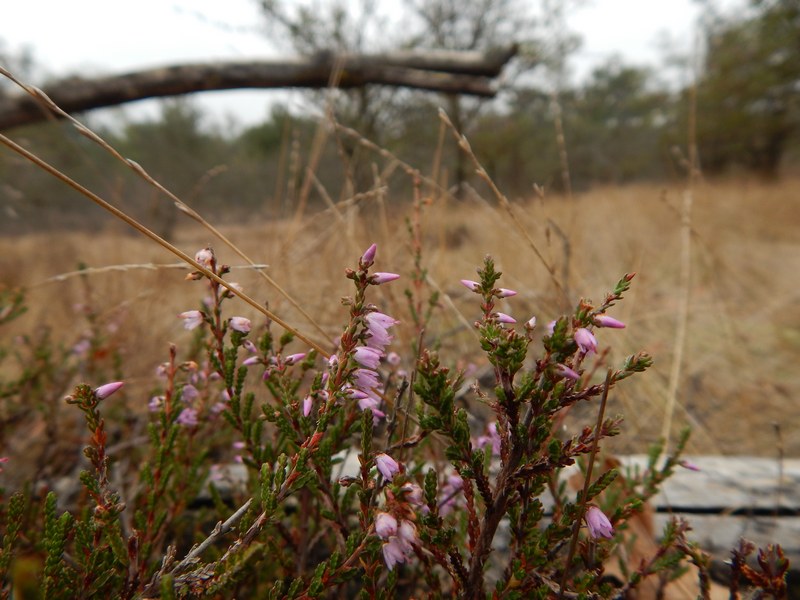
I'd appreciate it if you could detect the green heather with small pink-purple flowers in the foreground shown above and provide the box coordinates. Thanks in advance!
[0,67,788,598]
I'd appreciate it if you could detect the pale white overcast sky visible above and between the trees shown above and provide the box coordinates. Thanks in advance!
[0,0,736,129]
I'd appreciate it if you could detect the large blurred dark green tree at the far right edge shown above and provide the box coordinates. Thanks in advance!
[697,0,800,178]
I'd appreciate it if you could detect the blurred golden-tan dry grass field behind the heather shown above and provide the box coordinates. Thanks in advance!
[0,174,800,456]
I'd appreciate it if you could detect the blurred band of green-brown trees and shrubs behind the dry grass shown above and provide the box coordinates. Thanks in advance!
[0,0,800,233]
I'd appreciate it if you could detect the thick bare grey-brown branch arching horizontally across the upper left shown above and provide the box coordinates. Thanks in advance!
[0,47,516,130]
